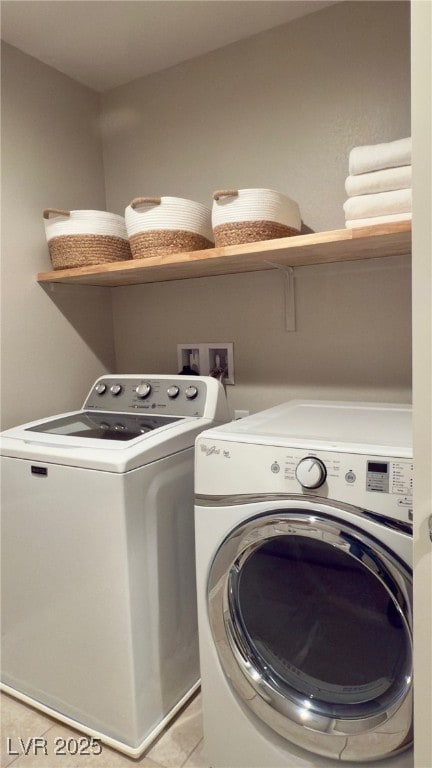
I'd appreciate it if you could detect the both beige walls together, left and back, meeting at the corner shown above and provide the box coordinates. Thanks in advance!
[2,2,411,426]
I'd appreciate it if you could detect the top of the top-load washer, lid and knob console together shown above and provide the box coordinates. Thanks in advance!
[0,374,228,473]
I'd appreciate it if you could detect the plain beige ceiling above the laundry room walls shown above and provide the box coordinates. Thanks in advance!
[1,0,336,92]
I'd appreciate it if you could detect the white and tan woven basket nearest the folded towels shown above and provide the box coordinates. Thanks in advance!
[212,189,301,247]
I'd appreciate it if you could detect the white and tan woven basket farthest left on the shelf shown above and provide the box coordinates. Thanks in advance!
[43,208,132,269]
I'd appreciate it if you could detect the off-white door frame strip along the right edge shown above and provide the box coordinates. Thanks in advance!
[412,0,432,768]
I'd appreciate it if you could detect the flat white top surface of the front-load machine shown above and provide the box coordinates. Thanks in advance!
[201,400,412,457]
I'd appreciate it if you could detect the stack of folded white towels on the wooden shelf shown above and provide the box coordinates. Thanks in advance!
[343,137,412,228]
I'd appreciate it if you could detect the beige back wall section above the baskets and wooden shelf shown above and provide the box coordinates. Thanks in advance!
[102,0,410,232]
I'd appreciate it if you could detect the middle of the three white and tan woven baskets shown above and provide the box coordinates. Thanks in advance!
[125,197,213,259]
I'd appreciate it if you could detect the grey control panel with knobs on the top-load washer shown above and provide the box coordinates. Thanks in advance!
[83,376,207,416]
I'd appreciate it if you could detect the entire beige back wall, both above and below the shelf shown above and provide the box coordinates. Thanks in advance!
[102,1,411,411]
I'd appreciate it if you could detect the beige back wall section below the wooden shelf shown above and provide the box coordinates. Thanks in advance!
[109,257,411,411]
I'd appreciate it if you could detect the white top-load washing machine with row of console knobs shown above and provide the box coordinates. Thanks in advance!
[1,375,228,756]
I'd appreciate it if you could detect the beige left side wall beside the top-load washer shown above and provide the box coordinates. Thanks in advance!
[1,43,115,429]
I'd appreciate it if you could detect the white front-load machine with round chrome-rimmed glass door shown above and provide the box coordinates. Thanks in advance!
[195,401,413,768]
